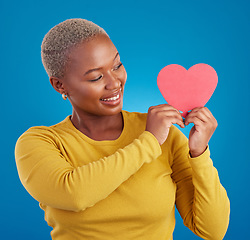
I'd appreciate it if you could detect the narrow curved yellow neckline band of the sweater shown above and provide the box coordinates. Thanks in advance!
[65,110,127,145]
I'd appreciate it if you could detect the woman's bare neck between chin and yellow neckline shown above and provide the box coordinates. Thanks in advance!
[71,110,123,141]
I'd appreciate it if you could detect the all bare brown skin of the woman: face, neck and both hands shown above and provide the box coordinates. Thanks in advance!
[50,34,217,157]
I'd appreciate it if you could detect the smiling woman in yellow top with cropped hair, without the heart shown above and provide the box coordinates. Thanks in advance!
[15,19,229,240]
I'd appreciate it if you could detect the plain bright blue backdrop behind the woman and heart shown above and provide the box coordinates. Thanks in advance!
[0,0,250,240]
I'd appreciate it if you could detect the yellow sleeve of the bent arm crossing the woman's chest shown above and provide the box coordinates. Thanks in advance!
[15,129,161,212]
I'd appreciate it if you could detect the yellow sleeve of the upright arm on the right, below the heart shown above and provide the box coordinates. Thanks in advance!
[172,128,230,240]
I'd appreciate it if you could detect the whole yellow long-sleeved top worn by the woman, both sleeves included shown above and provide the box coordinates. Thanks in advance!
[15,111,230,240]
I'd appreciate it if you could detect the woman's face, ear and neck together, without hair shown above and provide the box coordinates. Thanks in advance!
[50,34,127,140]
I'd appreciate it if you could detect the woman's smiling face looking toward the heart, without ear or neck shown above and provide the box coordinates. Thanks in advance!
[63,34,127,116]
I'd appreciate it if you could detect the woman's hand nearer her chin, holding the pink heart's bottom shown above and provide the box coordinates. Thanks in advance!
[146,104,185,145]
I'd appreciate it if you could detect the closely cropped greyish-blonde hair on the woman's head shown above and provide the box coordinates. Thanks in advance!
[41,18,107,78]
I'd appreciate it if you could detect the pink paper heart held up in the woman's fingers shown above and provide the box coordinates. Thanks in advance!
[157,63,218,118]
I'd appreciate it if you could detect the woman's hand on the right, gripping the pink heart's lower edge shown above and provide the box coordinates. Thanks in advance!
[184,107,218,157]
